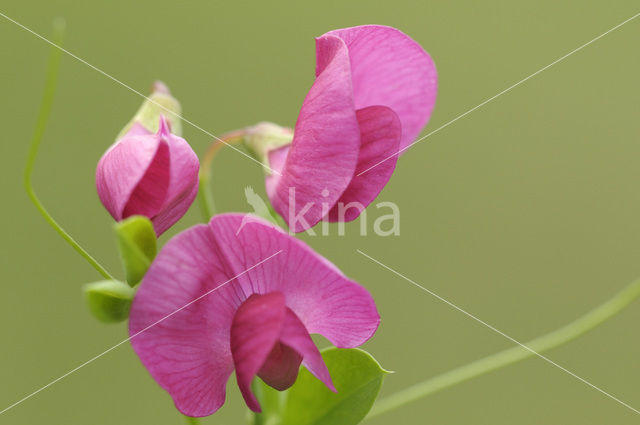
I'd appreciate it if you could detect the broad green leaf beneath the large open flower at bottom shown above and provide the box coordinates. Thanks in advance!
[254,348,389,425]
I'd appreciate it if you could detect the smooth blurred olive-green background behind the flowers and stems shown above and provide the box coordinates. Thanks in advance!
[0,0,640,425]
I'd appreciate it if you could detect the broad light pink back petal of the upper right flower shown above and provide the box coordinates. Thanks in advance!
[316,25,438,149]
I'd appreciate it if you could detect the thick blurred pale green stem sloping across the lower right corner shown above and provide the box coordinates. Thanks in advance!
[367,279,640,419]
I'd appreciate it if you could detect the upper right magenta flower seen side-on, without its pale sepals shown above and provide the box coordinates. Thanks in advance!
[266,25,437,232]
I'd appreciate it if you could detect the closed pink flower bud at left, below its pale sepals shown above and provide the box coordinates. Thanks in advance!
[96,116,200,236]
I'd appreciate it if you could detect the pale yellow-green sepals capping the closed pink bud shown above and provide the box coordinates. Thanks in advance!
[116,81,182,141]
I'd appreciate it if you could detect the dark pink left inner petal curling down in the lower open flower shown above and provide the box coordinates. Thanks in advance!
[231,292,286,412]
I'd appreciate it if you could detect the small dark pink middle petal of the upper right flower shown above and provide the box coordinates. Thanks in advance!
[329,106,402,222]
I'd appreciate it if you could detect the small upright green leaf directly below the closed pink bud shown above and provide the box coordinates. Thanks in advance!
[115,215,157,286]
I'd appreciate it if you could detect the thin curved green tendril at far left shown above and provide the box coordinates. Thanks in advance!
[24,20,113,279]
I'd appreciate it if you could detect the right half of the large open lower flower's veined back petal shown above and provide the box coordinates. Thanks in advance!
[209,214,380,348]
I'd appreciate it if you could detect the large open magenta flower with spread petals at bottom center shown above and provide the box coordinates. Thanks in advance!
[129,214,380,416]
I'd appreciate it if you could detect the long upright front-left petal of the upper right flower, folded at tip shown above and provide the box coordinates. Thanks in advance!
[266,37,360,232]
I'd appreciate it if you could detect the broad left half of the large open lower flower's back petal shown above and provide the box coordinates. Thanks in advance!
[129,225,239,416]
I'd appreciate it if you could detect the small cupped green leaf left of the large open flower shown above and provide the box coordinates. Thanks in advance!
[83,280,136,323]
